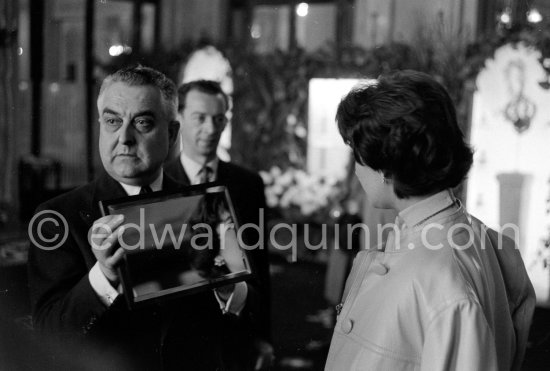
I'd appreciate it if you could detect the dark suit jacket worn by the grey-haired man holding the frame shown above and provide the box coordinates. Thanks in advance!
[28,174,253,370]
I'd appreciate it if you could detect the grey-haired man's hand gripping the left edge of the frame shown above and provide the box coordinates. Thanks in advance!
[89,215,124,286]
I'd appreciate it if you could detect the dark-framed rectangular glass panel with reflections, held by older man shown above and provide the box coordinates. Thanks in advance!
[103,186,250,304]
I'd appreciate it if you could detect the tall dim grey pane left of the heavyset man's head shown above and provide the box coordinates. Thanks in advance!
[41,0,87,188]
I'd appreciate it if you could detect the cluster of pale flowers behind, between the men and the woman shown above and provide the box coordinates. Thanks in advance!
[260,166,339,222]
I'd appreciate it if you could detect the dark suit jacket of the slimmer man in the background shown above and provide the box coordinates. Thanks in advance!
[164,156,271,340]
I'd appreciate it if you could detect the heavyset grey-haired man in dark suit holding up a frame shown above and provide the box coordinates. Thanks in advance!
[29,66,262,370]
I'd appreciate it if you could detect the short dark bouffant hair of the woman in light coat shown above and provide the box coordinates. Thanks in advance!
[336,71,473,198]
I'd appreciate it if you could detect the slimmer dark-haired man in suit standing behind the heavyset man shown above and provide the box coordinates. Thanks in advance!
[165,80,272,368]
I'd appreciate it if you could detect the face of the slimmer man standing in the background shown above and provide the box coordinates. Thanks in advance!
[178,90,227,163]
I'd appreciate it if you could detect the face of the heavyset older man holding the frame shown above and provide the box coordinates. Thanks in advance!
[97,82,178,186]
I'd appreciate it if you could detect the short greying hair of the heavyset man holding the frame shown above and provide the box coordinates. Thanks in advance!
[99,65,178,119]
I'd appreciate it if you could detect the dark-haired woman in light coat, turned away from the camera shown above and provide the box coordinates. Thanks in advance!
[326,71,535,371]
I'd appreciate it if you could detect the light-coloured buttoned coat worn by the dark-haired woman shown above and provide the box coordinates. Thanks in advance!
[325,192,535,371]
